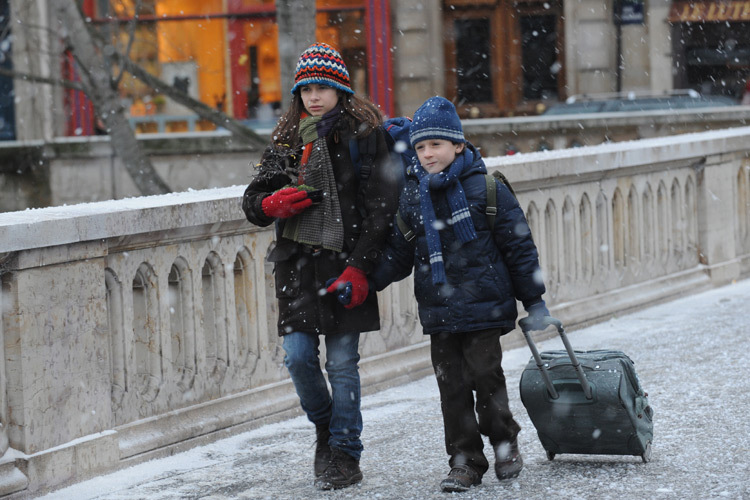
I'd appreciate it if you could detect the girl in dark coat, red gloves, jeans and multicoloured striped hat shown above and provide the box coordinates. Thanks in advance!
[242,43,398,489]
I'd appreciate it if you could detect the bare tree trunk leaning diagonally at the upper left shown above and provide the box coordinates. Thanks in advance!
[52,0,170,195]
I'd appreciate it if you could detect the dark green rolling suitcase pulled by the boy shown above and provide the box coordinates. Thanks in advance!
[520,318,653,462]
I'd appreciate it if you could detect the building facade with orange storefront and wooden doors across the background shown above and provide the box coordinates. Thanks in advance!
[0,0,750,139]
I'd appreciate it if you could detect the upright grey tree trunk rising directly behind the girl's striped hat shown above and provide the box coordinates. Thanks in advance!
[276,0,316,109]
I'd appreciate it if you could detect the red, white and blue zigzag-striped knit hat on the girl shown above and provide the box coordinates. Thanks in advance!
[292,43,354,94]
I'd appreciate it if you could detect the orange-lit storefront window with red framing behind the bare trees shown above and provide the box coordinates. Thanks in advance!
[87,0,368,132]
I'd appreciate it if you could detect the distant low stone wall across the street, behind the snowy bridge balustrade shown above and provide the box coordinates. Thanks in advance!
[0,105,750,212]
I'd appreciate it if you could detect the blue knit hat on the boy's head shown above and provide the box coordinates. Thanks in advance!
[409,96,466,147]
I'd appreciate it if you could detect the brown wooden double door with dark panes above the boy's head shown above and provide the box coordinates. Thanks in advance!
[443,0,564,118]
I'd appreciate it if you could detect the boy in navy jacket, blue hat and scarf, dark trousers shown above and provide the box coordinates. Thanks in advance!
[371,97,549,492]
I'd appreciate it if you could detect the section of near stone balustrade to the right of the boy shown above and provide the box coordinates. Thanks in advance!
[487,127,750,324]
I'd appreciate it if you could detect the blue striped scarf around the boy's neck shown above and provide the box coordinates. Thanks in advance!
[412,149,477,285]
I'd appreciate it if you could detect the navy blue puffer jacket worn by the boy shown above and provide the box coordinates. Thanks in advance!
[370,143,546,334]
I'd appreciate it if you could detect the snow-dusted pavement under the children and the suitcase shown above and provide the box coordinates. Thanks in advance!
[42,280,750,500]
